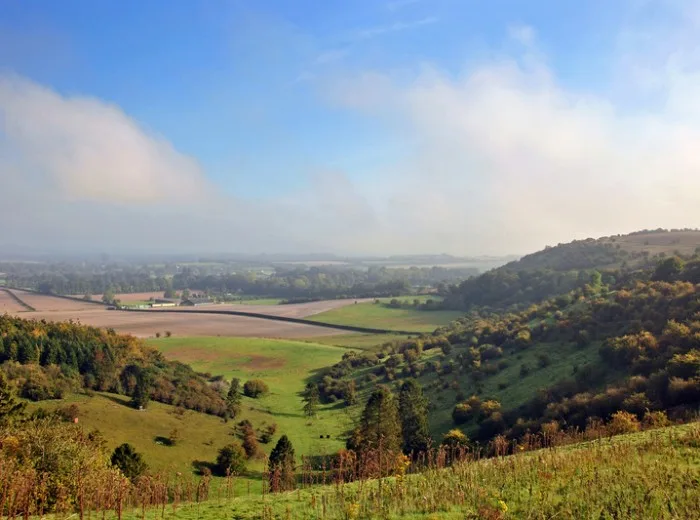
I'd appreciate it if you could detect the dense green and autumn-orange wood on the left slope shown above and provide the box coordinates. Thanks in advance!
[0,315,229,416]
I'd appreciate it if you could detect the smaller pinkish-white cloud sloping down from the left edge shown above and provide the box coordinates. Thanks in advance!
[0,76,209,204]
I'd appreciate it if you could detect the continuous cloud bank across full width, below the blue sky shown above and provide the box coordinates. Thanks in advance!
[0,3,700,254]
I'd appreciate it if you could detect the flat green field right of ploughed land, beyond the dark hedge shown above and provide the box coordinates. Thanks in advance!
[309,299,462,332]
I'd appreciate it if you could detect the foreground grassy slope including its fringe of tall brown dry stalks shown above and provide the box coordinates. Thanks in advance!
[8,423,700,520]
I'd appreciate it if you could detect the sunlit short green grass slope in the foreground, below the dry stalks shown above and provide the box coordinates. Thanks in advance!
[116,423,700,520]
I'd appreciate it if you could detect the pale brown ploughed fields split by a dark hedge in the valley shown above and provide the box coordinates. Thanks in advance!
[0,290,354,338]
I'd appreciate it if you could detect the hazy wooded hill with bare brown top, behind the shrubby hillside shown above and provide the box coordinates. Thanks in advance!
[444,229,700,310]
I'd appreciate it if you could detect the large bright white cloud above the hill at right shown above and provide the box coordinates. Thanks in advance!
[322,18,700,253]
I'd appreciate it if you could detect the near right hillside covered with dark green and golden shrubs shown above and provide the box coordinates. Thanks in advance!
[321,255,700,442]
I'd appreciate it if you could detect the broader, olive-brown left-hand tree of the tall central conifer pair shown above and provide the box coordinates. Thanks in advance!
[358,386,403,452]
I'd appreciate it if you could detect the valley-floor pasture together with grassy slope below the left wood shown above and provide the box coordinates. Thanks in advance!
[30,337,356,492]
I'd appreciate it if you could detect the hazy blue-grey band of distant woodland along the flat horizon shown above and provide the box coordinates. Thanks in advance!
[0,264,478,299]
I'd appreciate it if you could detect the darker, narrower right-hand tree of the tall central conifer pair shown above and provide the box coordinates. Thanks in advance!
[399,378,430,454]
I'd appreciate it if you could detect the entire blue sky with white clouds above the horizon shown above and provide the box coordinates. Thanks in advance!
[0,0,700,255]
